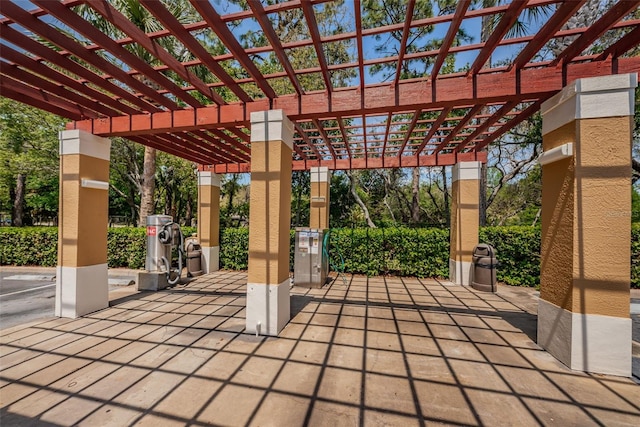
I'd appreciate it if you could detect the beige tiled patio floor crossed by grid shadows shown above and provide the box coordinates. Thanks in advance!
[0,271,640,426]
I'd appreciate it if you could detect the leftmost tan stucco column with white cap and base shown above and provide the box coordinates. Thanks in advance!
[55,130,111,318]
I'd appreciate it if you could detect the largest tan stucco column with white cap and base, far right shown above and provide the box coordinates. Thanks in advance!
[538,74,637,376]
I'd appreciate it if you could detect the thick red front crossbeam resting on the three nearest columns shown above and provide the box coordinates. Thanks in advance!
[72,57,640,136]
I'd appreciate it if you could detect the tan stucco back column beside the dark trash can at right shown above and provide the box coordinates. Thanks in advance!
[449,162,482,286]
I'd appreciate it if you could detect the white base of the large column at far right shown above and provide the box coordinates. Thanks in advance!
[538,300,632,377]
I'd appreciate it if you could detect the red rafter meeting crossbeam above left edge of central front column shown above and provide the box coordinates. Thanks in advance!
[140,0,251,102]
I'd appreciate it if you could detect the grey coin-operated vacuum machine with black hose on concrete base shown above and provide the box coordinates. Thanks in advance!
[138,215,202,291]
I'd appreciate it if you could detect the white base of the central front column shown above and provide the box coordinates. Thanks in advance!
[246,279,291,336]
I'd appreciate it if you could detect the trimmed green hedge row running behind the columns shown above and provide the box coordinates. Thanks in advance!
[0,224,640,288]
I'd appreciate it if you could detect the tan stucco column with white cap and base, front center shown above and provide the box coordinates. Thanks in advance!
[246,110,293,335]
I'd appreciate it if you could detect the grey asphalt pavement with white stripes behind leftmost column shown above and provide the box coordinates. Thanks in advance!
[0,267,137,329]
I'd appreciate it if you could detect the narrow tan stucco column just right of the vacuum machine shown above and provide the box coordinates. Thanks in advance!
[198,171,220,273]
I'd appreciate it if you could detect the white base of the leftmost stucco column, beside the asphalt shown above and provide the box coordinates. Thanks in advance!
[55,264,109,319]
